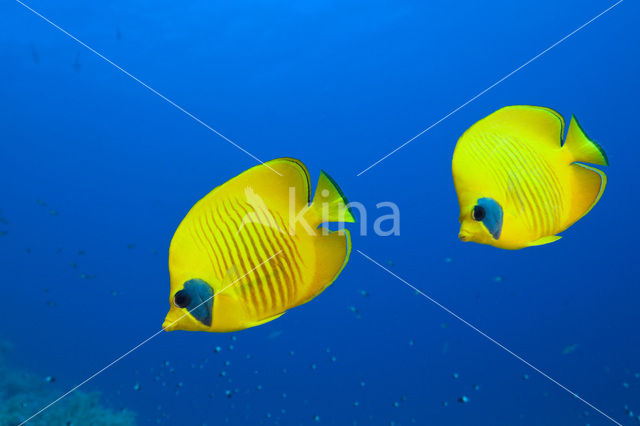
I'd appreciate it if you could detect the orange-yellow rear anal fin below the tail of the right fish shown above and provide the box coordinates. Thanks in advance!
[566,163,607,227]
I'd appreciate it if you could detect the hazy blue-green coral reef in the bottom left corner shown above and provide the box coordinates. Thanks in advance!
[0,341,135,426]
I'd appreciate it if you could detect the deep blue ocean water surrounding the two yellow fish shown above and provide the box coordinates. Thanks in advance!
[0,0,640,425]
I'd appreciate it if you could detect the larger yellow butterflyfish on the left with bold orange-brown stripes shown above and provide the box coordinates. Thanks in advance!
[163,158,355,332]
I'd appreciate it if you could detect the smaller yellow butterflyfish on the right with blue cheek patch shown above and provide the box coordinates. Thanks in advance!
[452,105,609,249]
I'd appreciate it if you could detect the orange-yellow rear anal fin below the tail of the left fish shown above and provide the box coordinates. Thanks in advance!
[301,229,351,303]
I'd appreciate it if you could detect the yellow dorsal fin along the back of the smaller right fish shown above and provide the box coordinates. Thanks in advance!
[472,105,564,148]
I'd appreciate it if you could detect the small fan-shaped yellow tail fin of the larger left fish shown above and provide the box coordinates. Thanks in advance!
[309,170,356,226]
